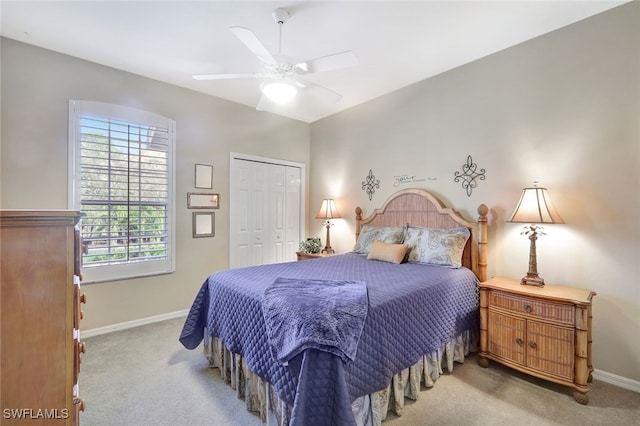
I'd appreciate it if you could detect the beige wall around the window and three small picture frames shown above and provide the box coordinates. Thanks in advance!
[0,39,309,329]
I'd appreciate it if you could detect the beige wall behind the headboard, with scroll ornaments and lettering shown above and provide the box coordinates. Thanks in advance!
[308,2,640,381]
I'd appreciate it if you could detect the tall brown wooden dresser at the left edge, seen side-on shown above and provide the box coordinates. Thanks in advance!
[0,210,86,425]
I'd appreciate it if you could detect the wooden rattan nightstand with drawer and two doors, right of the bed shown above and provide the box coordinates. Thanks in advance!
[478,277,596,404]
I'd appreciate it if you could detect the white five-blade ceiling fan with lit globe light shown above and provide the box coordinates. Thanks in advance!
[192,8,358,115]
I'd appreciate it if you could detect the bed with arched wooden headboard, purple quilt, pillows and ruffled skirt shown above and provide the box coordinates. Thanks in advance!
[179,189,488,426]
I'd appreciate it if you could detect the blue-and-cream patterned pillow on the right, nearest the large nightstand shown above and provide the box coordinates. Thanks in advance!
[404,227,471,268]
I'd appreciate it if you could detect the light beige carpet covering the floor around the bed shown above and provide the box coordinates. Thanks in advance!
[80,319,640,426]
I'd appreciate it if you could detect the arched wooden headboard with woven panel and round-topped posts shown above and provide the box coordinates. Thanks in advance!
[356,189,489,281]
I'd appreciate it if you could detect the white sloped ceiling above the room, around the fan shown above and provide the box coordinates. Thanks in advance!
[0,0,626,122]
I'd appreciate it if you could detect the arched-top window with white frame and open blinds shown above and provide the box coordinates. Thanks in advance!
[69,101,175,282]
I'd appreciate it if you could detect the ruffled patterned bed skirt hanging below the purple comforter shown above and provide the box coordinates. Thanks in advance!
[203,331,478,426]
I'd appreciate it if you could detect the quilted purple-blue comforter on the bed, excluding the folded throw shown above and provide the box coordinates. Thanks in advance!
[180,254,478,425]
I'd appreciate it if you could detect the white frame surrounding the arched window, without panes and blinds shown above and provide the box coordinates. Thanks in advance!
[68,100,176,283]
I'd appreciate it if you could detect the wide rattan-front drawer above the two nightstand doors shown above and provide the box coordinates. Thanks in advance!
[489,291,575,325]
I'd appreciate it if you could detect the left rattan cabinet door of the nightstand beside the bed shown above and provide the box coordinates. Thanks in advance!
[488,309,526,365]
